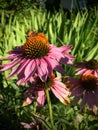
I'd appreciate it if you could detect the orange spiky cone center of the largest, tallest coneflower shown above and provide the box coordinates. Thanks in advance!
[23,31,49,59]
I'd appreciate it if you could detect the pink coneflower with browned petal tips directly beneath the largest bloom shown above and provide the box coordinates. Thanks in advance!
[23,75,70,106]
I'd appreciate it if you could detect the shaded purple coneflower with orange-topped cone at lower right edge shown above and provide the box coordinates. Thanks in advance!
[67,74,98,109]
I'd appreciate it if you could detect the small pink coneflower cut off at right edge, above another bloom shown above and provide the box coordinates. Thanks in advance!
[76,59,98,77]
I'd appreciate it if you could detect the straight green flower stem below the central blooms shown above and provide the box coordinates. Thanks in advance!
[45,88,55,130]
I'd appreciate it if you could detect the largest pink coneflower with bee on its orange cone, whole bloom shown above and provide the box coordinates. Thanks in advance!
[0,31,75,85]
